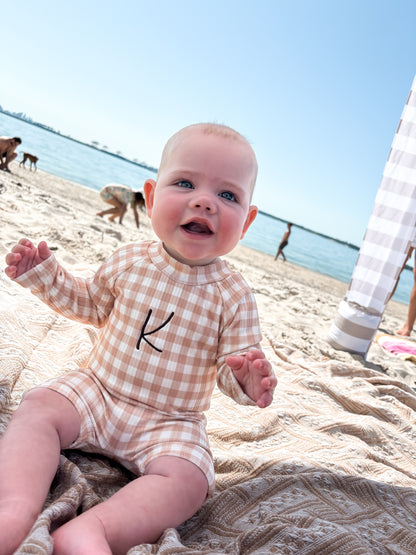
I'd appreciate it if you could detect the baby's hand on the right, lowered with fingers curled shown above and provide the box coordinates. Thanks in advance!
[225,349,277,409]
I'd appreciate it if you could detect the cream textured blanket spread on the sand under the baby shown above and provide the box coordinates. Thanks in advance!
[0,280,416,555]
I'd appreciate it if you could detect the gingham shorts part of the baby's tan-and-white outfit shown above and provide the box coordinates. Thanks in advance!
[42,370,215,494]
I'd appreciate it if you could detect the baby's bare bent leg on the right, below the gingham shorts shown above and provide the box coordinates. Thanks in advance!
[53,456,208,555]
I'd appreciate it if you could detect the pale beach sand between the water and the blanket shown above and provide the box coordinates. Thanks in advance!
[0,163,416,388]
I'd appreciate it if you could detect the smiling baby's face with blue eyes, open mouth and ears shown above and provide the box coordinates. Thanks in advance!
[144,128,257,266]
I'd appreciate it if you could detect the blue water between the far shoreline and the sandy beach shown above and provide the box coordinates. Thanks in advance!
[0,112,413,304]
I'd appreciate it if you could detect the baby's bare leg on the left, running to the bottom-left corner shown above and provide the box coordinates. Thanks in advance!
[0,388,80,555]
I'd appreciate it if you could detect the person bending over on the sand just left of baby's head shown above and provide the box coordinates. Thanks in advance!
[97,183,145,228]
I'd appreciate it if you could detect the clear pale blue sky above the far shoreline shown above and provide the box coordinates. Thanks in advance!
[0,0,416,244]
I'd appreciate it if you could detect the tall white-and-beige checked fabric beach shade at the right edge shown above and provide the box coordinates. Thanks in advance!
[326,77,416,356]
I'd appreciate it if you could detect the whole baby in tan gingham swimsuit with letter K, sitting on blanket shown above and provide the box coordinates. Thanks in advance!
[0,124,277,555]
